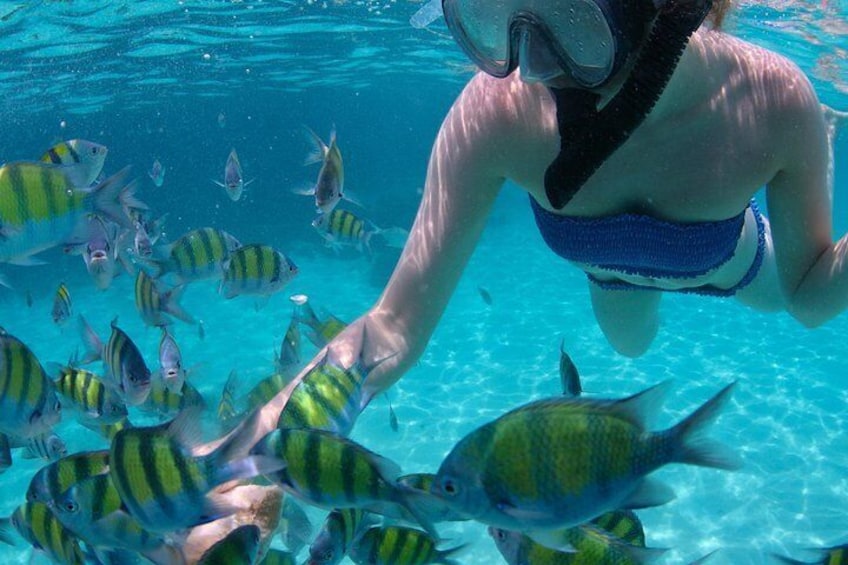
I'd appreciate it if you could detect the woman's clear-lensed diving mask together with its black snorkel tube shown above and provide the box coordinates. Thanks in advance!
[440,0,712,209]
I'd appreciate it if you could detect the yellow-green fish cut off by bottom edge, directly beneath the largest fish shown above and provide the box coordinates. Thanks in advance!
[489,523,666,565]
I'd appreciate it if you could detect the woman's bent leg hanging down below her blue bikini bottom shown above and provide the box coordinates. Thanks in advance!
[589,281,662,357]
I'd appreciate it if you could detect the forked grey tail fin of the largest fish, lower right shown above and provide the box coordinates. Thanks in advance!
[667,381,742,471]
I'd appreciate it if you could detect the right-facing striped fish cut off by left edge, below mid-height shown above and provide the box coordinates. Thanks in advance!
[0,328,62,438]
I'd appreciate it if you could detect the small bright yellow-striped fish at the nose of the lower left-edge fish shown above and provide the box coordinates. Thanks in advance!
[56,367,127,424]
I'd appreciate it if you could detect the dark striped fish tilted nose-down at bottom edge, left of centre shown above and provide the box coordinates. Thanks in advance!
[304,508,378,565]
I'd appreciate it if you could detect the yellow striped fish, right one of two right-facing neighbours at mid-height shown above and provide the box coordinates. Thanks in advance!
[219,245,298,299]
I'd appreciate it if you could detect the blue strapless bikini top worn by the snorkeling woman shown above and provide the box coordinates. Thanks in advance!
[530,196,756,278]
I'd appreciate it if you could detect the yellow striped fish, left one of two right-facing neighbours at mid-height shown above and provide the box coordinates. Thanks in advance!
[141,228,241,284]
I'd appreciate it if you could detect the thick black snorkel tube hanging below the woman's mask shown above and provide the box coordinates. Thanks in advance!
[545,0,712,210]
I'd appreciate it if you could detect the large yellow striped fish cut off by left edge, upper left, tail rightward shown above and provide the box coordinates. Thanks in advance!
[0,162,139,265]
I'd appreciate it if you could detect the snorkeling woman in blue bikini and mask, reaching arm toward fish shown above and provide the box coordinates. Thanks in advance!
[266,0,848,418]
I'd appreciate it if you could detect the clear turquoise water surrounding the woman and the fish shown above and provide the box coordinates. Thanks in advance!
[0,0,848,564]
